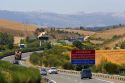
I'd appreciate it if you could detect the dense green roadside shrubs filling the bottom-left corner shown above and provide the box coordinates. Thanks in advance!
[0,61,41,83]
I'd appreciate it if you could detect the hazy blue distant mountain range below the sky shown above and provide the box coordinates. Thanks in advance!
[0,10,125,27]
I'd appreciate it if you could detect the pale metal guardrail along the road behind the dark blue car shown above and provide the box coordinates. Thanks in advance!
[58,69,125,81]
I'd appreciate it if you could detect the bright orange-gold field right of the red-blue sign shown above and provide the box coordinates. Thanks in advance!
[96,50,125,64]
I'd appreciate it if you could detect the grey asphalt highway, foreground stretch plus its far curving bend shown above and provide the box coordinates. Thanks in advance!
[2,51,125,83]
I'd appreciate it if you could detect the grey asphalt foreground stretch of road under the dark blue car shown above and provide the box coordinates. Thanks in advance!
[47,73,125,83]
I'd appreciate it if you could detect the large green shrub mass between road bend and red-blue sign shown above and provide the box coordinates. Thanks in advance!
[30,47,69,67]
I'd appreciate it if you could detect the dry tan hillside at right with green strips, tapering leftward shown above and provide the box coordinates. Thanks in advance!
[60,27,125,49]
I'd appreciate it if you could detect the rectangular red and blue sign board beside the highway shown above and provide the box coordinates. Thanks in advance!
[71,50,95,64]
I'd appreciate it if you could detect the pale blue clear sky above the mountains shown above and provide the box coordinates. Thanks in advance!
[0,0,125,14]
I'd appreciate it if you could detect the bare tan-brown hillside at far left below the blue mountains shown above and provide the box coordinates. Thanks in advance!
[0,19,36,36]
